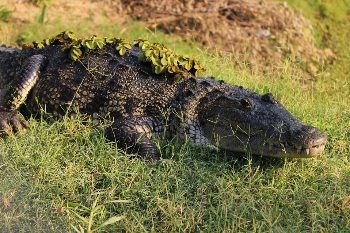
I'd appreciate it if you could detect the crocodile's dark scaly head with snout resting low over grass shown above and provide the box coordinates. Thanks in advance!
[197,82,327,158]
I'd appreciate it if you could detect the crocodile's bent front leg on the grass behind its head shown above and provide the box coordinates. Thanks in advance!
[105,117,163,160]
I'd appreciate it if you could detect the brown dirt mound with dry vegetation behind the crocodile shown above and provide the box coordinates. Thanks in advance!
[118,0,335,74]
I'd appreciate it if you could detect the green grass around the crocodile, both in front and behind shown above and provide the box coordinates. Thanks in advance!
[0,1,350,232]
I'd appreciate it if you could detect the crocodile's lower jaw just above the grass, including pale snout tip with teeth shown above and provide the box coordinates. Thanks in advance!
[203,125,327,158]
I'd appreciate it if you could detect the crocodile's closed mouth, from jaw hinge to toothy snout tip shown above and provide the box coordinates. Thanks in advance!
[202,111,327,158]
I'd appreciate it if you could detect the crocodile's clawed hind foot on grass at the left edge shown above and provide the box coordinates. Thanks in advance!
[0,111,28,137]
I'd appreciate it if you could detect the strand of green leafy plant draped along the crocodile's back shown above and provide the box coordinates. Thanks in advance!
[33,31,204,80]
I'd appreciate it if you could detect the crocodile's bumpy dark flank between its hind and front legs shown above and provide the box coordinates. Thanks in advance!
[28,46,180,121]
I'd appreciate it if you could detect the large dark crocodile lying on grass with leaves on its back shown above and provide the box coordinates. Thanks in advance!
[0,32,327,160]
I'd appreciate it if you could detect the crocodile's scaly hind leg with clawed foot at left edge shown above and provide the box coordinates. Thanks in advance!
[0,55,45,136]
